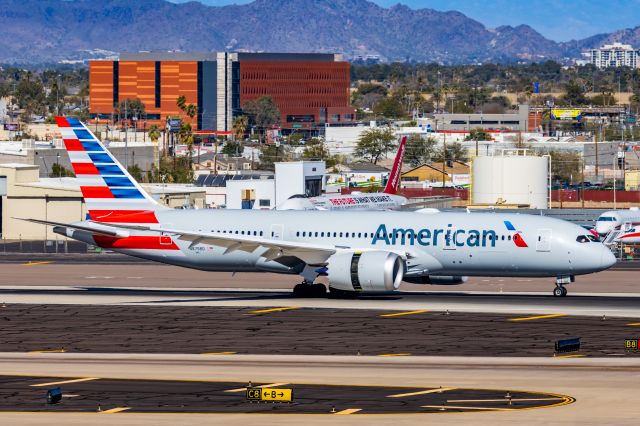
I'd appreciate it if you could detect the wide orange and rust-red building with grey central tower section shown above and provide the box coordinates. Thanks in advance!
[89,52,355,131]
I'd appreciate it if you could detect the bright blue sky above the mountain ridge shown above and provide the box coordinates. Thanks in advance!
[171,0,640,41]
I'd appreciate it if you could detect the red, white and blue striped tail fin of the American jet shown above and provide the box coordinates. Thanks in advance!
[55,117,166,223]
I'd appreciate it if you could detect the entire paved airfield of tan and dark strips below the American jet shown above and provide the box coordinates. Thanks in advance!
[0,258,640,426]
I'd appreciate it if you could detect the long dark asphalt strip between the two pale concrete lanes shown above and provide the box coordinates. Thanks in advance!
[0,301,640,358]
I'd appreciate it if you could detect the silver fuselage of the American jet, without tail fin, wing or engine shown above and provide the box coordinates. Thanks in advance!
[67,210,615,277]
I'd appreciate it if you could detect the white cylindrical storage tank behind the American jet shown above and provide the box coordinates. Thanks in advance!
[472,150,549,209]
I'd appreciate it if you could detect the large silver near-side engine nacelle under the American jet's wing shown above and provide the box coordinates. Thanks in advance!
[327,251,404,292]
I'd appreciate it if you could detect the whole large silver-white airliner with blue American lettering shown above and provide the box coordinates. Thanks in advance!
[22,117,616,296]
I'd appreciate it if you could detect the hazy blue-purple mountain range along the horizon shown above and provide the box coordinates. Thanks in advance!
[0,0,640,64]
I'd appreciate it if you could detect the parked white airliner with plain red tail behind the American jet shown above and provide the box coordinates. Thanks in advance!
[277,136,407,210]
